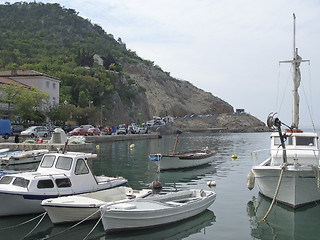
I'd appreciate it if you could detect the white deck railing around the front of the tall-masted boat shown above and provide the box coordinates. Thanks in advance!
[251,148,320,166]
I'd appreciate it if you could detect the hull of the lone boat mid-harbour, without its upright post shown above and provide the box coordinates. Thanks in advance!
[159,150,215,171]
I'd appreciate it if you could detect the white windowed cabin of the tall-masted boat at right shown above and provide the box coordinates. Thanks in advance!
[271,131,319,166]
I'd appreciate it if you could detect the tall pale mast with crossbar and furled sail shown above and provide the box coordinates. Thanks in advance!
[280,14,310,128]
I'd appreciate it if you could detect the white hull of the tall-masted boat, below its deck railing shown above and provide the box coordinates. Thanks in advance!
[252,165,320,208]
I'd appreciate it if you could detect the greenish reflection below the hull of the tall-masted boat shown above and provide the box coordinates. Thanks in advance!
[247,194,320,240]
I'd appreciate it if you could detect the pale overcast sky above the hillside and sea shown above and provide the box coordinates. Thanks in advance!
[0,0,320,128]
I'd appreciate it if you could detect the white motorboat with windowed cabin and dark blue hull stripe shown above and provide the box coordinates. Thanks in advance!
[0,152,127,216]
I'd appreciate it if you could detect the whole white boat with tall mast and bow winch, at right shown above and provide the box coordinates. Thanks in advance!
[247,14,320,209]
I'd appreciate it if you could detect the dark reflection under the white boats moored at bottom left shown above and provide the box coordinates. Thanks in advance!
[0,210,216,240]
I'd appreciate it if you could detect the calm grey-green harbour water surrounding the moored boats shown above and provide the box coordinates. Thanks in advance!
[0,133,320,240]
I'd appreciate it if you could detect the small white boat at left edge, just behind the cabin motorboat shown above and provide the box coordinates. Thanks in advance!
[0,149,49,166]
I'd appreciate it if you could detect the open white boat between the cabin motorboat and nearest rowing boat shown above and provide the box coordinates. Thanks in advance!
[41,187,152,224]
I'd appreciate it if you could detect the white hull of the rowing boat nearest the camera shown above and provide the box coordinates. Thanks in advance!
[101,190,216,232]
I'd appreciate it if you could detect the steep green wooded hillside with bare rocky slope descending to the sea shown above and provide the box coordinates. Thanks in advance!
[0,2,264,130]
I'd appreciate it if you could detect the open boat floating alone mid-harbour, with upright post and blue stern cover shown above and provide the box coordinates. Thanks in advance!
[149,132,216,172]
